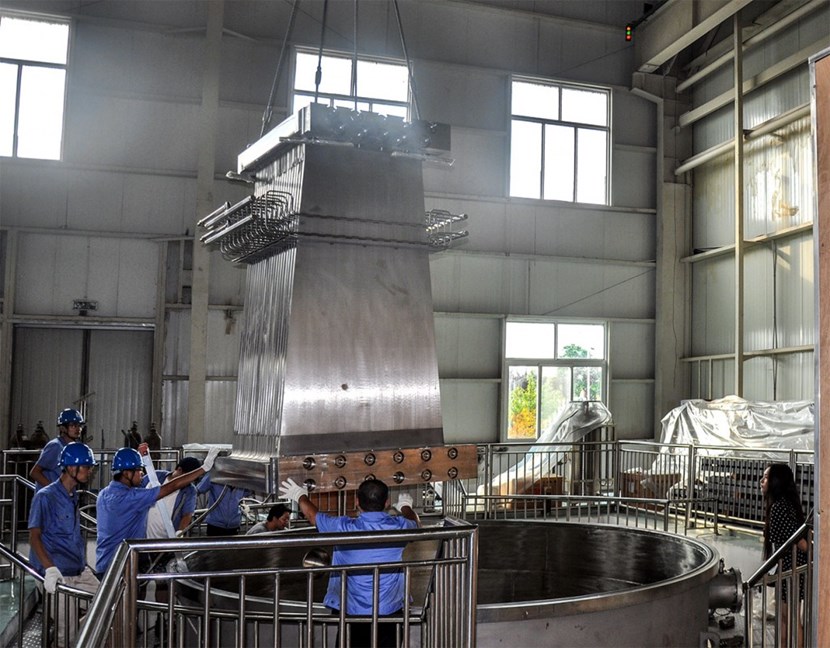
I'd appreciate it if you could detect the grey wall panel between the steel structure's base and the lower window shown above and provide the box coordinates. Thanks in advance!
[440,380,500,443]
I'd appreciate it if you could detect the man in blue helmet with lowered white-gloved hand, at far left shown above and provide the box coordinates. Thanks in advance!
[29,442,99,646]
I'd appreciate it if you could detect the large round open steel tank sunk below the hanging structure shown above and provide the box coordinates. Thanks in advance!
[182,520,719,648]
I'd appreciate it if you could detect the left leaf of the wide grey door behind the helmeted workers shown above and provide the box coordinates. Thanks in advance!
[10,327,82,430]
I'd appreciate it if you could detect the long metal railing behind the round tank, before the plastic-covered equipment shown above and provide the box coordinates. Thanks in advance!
[468,441,814,527]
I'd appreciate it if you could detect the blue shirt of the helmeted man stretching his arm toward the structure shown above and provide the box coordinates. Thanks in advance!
[95,481,159,574]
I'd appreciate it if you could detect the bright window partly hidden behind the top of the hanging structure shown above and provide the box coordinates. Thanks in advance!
[293,51,409,119]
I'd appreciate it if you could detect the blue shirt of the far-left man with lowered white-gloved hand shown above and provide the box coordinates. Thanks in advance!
[29,481,86,577]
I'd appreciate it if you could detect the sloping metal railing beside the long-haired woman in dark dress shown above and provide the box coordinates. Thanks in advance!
[743,520,813,648]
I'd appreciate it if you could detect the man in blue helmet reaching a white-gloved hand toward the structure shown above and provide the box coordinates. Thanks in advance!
[95,443,219,576]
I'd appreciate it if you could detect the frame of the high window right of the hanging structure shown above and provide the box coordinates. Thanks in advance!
[506,74,613,207]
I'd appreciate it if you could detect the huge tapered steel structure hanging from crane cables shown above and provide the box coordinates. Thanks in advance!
[200,104,475,492]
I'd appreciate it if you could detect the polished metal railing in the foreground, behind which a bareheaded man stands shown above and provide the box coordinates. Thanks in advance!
[78,520,478,648]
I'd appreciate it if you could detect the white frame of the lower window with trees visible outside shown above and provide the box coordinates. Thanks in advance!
[499,316,611,443]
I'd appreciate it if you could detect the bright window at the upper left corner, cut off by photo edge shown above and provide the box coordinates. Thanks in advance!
[0,15,69,160]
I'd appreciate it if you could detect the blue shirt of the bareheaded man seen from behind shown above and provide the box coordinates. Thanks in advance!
[317,511,418,616]
